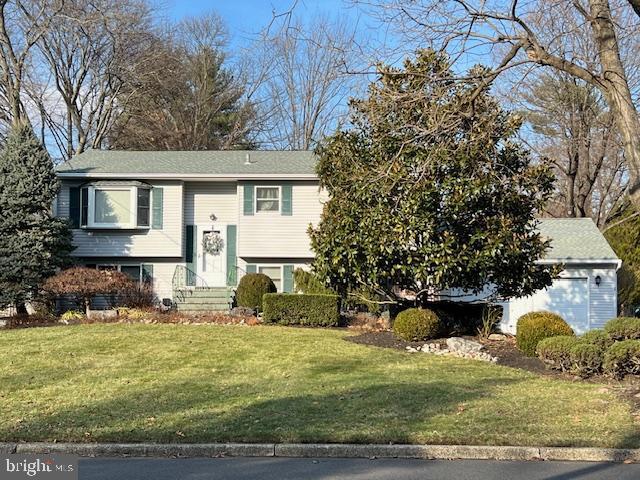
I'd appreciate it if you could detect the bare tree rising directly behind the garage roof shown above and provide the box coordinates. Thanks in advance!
[522,71,626,226]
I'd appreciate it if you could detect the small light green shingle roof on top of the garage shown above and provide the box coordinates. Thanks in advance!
[539,218,618,261]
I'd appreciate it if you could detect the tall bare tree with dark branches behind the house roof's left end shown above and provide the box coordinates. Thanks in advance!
[26,0,154,159]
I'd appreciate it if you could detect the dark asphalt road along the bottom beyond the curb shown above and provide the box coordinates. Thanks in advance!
[78,458,640,480]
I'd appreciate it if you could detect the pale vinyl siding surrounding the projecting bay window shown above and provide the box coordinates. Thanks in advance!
[57,181,183,257]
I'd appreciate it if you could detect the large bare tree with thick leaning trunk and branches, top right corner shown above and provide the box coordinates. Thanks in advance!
[362,0,640,205]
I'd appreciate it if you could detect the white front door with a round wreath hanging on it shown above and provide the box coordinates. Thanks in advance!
[196,224,227,287]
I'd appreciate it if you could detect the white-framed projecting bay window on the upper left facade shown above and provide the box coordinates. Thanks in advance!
[80,185,151,229]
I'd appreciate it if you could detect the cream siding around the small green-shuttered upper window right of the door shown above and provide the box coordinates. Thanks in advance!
[237,181,327,258]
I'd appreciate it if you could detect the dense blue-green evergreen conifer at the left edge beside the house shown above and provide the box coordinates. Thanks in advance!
[0,123,73,311]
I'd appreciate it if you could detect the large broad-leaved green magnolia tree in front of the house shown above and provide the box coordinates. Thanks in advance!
[310,50,554,302]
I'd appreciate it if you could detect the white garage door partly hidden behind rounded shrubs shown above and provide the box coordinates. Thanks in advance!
[511,278,589,334]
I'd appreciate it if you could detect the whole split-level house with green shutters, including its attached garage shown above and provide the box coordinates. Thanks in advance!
[55,150,620,332]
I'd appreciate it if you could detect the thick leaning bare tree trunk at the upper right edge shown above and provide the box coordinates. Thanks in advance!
[589,0,640,207]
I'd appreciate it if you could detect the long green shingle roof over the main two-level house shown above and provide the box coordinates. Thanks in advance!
[56,150,317,179]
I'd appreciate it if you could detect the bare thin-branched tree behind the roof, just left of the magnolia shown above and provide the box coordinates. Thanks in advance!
[251,14,358,150]
